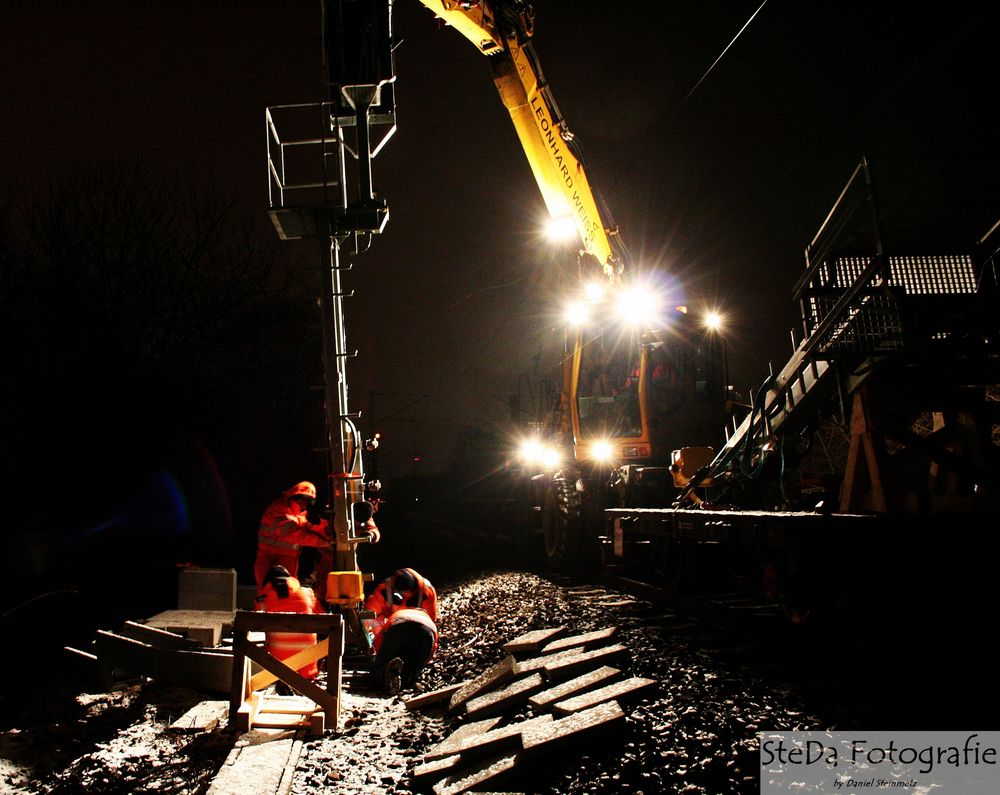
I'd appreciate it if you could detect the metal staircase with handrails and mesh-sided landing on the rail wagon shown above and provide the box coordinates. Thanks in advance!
[682,160,981,501]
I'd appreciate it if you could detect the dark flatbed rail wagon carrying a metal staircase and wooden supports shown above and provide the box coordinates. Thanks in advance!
[600,155,1000,618]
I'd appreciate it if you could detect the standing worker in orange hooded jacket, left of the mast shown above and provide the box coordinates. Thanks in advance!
[254,480,333,592]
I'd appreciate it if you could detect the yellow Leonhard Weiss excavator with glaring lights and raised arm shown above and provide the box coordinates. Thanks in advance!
[421,0,732,569]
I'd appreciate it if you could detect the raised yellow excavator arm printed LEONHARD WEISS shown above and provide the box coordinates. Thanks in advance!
[420,0,625,281]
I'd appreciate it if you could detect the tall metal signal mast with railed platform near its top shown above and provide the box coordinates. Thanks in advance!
[265,0,396,571]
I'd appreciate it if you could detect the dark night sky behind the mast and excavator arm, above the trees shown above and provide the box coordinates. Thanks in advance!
[0,0,997,516]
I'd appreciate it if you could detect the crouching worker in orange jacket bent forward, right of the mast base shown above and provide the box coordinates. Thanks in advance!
[364,569,438,694]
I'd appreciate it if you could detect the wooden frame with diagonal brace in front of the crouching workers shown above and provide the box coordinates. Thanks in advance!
[229,610,344,734]
